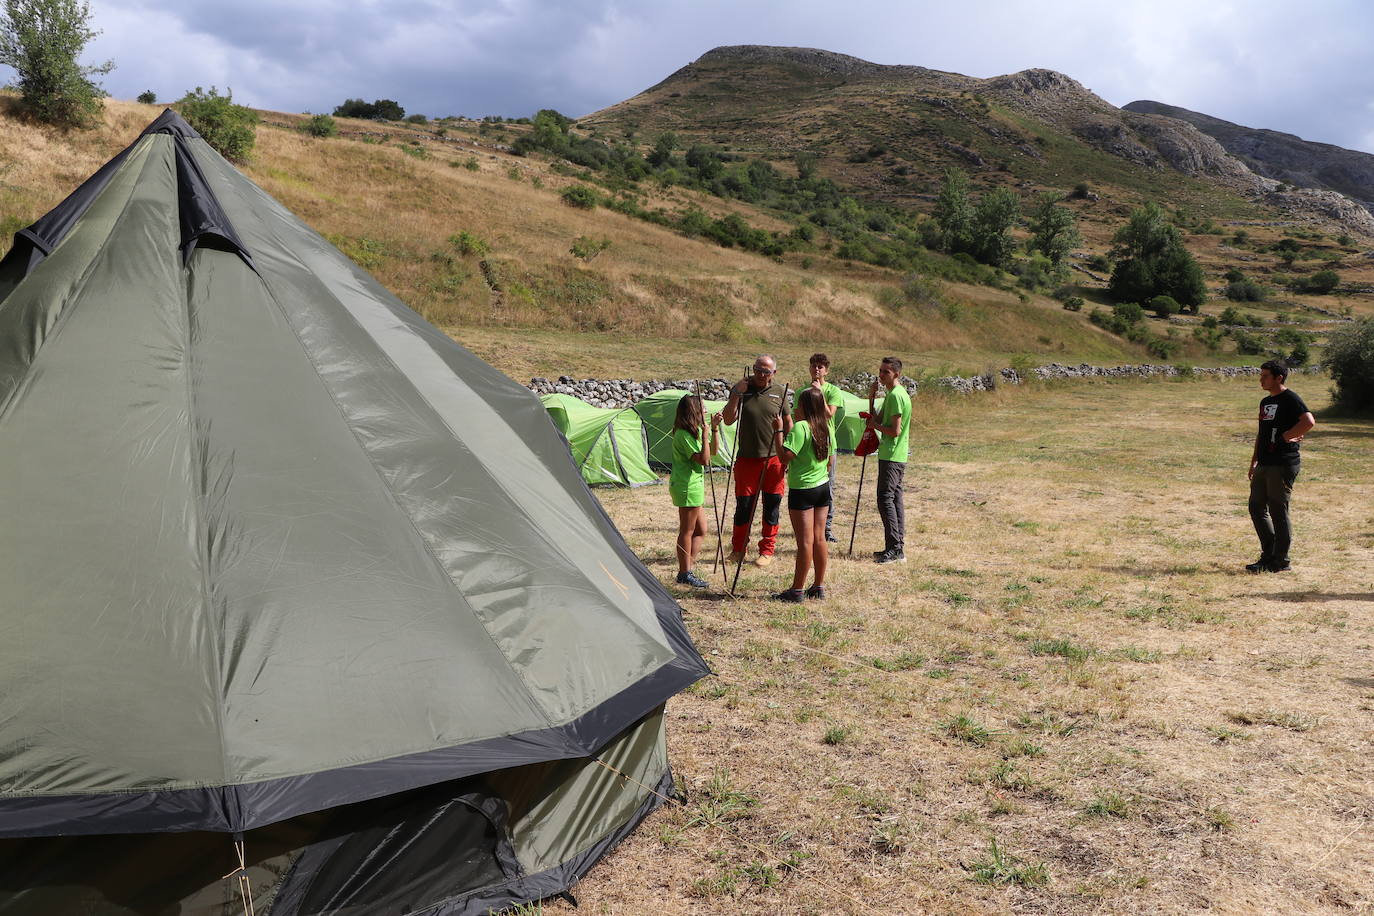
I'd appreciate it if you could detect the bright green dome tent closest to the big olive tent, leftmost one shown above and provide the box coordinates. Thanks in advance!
[540,394,658,486]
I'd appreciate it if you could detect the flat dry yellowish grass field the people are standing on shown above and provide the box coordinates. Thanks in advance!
[543,376,1374,915]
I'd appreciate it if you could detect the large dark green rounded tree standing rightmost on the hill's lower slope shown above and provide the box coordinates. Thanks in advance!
[1107,201,1206,312]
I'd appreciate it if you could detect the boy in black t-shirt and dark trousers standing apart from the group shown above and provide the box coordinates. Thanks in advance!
[1245,360,1316,573]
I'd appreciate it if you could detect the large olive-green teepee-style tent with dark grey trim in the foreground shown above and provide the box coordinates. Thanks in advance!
[0,111,706,916]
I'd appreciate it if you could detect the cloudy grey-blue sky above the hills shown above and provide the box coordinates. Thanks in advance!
[64,0,1374,152]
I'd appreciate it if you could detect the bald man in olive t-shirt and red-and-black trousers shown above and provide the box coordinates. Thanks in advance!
[721,356,786,566]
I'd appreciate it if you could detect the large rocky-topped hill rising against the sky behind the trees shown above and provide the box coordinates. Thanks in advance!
[580,45,1374,233]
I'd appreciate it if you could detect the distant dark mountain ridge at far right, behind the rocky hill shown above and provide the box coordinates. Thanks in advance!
[1124,100,1374,209]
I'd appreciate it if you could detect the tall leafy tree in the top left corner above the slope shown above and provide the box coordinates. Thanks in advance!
[0,0,114,128]
